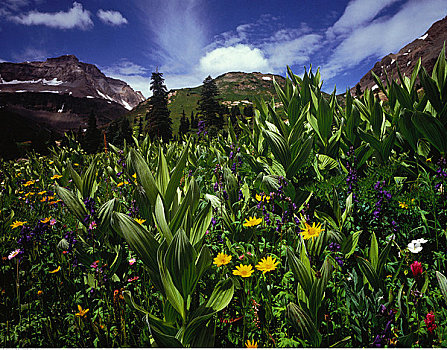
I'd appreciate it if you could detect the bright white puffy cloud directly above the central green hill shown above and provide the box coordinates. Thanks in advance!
[200,44,270,77]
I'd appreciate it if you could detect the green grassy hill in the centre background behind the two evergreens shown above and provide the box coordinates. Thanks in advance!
[129,72,285,133]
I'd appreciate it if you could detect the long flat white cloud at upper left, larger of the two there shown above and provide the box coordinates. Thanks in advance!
[9,2,93,30]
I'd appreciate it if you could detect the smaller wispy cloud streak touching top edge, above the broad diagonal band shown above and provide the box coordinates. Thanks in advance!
[326,0,400,38]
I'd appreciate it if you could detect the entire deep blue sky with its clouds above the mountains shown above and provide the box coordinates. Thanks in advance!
[0,0,447,96]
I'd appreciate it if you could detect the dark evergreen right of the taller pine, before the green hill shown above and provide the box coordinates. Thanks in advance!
[198,76,224,135]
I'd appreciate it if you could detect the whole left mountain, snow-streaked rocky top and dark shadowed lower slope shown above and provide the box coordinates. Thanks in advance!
[0,55,144,142]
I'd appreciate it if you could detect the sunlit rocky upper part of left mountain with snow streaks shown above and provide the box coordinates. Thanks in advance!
[0,55,144,110]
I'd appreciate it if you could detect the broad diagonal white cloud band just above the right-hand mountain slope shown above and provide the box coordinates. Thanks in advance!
[321,0,447,79]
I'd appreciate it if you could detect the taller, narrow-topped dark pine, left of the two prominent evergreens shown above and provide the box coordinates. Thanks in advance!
[146,71,172,142]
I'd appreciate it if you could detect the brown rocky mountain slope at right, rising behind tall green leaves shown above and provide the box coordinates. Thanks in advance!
[351,17,447,94]
